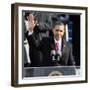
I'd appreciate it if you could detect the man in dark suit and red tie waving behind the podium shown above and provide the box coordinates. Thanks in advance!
[27,18,75,66]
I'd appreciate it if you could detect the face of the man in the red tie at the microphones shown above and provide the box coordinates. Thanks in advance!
[53,25,64,40]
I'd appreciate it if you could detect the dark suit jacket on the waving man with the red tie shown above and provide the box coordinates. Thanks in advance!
[28,33,75,66]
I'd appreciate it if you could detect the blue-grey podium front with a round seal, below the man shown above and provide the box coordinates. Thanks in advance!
[23,66,76,77]
